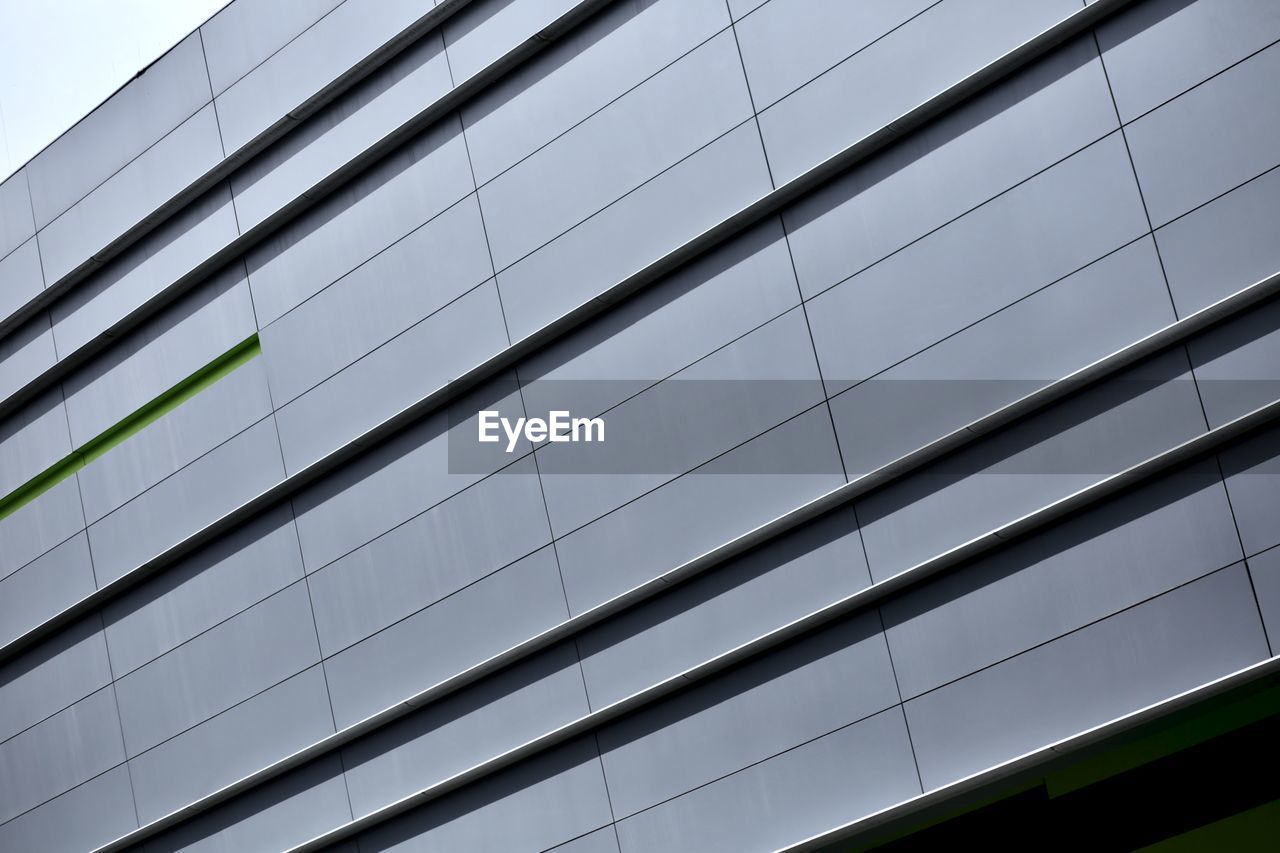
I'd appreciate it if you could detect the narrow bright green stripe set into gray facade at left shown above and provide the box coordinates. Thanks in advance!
[0,334,262,519]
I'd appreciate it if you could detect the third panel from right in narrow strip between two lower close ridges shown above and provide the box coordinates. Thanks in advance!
[577,507,870,708]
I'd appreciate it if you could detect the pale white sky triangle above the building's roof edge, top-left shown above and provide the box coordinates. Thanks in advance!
[0,0,227,181]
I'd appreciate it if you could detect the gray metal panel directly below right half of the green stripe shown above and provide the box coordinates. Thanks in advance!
[79,359,271,524]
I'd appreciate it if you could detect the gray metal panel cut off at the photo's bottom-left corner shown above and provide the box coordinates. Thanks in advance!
[0,765,138,853]
